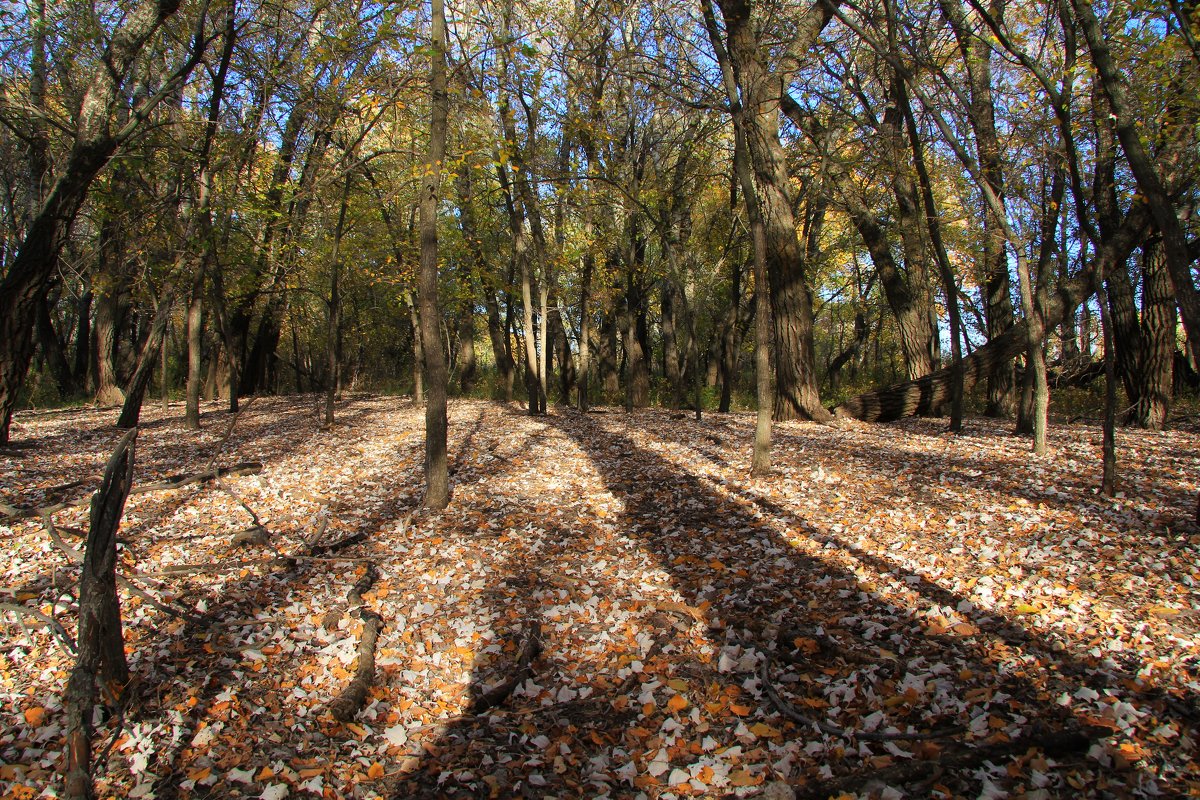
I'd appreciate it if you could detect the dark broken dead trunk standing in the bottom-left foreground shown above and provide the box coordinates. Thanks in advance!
[62,428,137,800]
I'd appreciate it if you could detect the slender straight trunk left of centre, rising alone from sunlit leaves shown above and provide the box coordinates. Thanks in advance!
[418,0,450,509]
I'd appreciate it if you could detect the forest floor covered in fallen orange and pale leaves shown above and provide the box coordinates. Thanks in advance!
[0,397,1200,800]
